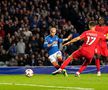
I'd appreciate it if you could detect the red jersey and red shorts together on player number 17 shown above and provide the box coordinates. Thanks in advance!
[72,30,105,60]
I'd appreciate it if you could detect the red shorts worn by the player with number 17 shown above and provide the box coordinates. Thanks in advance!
[72,49,94,62]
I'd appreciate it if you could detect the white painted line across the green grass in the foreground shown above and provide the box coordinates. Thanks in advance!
[0,83,94,90]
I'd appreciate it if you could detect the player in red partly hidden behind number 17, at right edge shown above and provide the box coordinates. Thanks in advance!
[95,17,108,76]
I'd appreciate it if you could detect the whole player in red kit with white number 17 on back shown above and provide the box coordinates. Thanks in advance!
[52,21,106,76]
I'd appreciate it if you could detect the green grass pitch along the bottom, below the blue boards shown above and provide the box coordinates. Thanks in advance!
[0,74,108,90]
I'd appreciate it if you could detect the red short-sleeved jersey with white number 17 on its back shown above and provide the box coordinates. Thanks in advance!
[80,30,106,51]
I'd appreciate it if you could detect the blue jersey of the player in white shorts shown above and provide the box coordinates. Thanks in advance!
[44,35,63,55]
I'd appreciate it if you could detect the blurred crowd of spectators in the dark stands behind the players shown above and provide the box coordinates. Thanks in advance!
[0,0,108,66]
